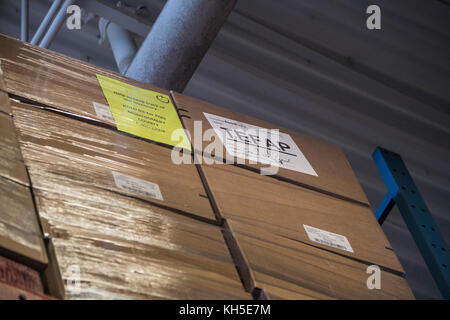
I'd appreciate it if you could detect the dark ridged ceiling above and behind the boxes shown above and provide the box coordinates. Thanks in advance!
[0,0,450,299]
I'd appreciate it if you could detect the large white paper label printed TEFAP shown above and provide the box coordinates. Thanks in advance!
[203,112,317,176]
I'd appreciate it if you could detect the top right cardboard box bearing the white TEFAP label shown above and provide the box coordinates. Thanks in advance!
[172,92,369,205]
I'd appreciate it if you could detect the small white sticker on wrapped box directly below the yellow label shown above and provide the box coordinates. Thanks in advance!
[112,171,164,200]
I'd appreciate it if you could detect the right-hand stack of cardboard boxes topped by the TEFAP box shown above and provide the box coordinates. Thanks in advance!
[172,92,413,299]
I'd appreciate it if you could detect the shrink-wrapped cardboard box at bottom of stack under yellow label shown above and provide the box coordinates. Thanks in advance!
[35,176,251,299]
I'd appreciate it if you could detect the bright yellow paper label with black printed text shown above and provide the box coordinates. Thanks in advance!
[97,74,191,150]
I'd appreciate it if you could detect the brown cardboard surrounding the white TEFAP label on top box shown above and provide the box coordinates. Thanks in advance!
[172,92,369,204]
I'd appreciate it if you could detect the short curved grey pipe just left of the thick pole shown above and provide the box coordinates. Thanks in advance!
[98,18,137,74]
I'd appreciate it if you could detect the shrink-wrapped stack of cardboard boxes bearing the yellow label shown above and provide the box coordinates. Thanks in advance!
[0,37,251,299]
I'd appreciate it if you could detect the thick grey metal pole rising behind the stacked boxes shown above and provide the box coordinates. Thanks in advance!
[125,0,236,92]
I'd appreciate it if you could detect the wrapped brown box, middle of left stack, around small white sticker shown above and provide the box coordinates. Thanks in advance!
[12,102,216,221]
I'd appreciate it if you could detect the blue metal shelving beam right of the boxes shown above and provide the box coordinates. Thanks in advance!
[372,147,450,299]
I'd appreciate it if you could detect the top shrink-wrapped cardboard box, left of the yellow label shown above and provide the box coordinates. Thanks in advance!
[0,34,169,125]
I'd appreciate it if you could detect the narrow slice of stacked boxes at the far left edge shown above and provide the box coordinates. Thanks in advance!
[0,92,48,299]
